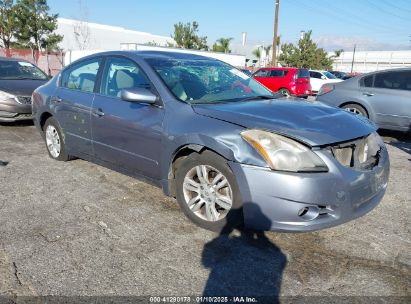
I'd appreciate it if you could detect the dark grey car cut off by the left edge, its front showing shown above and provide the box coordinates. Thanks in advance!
[0,57,48,122]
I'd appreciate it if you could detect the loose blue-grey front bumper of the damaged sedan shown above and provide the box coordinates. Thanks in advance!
[230,147,389,231]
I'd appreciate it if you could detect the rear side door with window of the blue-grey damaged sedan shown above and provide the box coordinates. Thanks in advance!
[51,57,102,156]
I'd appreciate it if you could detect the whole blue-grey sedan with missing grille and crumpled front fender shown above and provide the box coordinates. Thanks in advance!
[33,51,389,231]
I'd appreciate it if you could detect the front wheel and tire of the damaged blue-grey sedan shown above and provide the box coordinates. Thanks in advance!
[175,151,243,233]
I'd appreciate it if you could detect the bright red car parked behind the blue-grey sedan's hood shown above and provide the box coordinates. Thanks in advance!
[253,68,312,97]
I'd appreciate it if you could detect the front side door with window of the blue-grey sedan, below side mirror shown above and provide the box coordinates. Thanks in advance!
[91,57,164,179]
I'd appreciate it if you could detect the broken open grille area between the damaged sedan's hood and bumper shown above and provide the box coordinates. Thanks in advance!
[329,133,382,170]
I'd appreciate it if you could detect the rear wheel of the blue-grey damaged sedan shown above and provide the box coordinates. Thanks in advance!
[44,117,70,161]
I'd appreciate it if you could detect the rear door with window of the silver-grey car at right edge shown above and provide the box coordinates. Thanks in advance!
[360,70,411,131]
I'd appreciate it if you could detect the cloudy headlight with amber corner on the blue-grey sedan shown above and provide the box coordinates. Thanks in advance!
[241,130,328,172]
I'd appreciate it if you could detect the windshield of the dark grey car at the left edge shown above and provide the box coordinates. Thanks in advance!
[0,60,47,80]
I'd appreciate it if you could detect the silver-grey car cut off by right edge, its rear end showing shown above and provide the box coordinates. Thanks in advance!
[317,69,411,132]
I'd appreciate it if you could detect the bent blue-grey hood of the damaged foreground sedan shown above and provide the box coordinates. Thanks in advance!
[193,99,375,146]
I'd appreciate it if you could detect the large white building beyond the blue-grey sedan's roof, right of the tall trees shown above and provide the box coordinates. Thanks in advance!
[56,18,175,51]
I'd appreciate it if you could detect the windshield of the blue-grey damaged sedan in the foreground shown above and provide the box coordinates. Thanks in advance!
[147,58,275,104]
